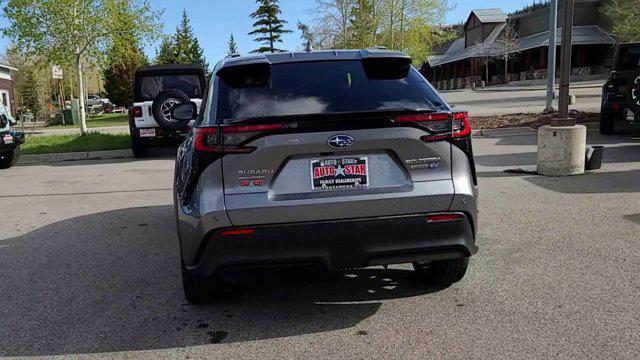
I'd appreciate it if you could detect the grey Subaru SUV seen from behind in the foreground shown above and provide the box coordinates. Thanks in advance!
[172,49,478,303]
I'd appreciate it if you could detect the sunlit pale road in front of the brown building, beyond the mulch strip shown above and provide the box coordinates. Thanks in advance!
[443,82,602,116]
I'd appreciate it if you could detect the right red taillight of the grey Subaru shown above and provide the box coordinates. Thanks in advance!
[395,111,471,141]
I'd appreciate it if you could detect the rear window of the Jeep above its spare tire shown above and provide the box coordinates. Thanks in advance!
[135,74,203,101]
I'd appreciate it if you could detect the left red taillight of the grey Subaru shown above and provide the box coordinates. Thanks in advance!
[195,124,284,154]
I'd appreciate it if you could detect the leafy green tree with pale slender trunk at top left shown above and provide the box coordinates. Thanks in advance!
[2,0,160,134]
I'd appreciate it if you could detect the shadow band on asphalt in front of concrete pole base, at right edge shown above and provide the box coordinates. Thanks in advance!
[525,170,640,194]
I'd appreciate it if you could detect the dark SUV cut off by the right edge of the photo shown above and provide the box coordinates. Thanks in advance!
[600,43,640,135]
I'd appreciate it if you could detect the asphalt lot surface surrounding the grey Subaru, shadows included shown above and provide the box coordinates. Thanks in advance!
[0,131,640,359]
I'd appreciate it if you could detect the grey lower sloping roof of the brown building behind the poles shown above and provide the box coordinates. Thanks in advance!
[428,25,616,67]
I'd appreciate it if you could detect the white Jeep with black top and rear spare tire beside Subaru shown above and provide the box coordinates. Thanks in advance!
[129,64,206,157]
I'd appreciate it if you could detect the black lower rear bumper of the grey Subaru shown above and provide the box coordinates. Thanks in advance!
[187,214,478,276]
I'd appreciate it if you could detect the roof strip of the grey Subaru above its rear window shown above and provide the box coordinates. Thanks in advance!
[213,47,411,73]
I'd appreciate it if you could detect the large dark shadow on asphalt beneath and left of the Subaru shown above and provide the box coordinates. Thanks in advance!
[0,206,439,356]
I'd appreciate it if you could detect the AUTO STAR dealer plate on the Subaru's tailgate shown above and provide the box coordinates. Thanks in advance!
[311,157,369,190]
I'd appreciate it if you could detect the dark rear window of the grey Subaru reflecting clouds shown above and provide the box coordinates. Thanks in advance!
[216,61,444,122]
